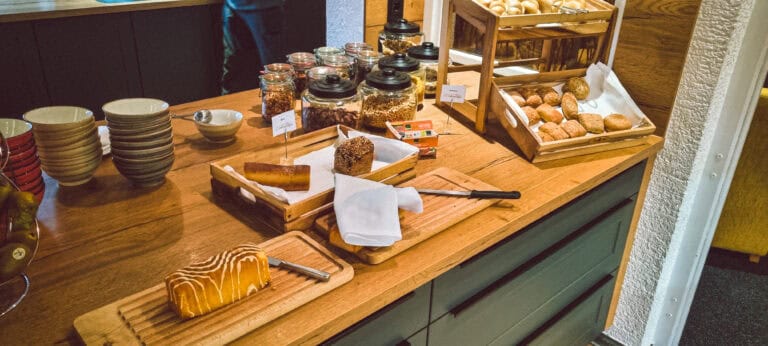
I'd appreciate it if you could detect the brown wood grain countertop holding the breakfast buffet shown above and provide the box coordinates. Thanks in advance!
[0,90,662,345]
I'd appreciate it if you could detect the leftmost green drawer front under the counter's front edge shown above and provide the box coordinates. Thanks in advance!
[324,282,432,345]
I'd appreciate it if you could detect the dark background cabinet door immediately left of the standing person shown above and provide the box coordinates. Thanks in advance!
[131,5,221,104]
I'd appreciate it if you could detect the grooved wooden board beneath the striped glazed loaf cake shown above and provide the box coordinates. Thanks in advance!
[74,232,354,345]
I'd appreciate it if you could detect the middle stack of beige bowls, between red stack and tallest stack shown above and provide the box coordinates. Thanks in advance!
[24,106,102,186]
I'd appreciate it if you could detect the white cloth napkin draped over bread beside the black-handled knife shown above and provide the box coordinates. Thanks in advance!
[333,173,423,247]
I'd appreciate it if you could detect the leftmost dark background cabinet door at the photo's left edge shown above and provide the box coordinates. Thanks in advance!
[0,22,50,119]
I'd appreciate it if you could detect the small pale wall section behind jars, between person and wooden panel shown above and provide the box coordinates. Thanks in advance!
[325,0,365,47]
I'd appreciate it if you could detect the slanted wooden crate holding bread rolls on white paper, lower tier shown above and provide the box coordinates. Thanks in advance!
[490,71,656,162]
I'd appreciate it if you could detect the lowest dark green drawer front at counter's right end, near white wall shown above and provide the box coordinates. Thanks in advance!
[524,275,616,346]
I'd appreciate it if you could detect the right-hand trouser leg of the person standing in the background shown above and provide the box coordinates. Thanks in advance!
[237,5,286,65]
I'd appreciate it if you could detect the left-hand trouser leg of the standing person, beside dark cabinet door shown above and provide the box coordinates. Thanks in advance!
[221,5,262,95]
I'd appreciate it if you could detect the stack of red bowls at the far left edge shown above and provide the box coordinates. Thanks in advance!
[0,119,45,201]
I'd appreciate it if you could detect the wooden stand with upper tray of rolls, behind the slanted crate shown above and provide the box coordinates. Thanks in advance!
[436,0,616,133]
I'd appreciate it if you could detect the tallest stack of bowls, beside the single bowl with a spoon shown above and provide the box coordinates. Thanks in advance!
[102,98,174,186]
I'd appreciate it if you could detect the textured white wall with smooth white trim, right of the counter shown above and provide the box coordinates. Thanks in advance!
[609,0,768,345]
